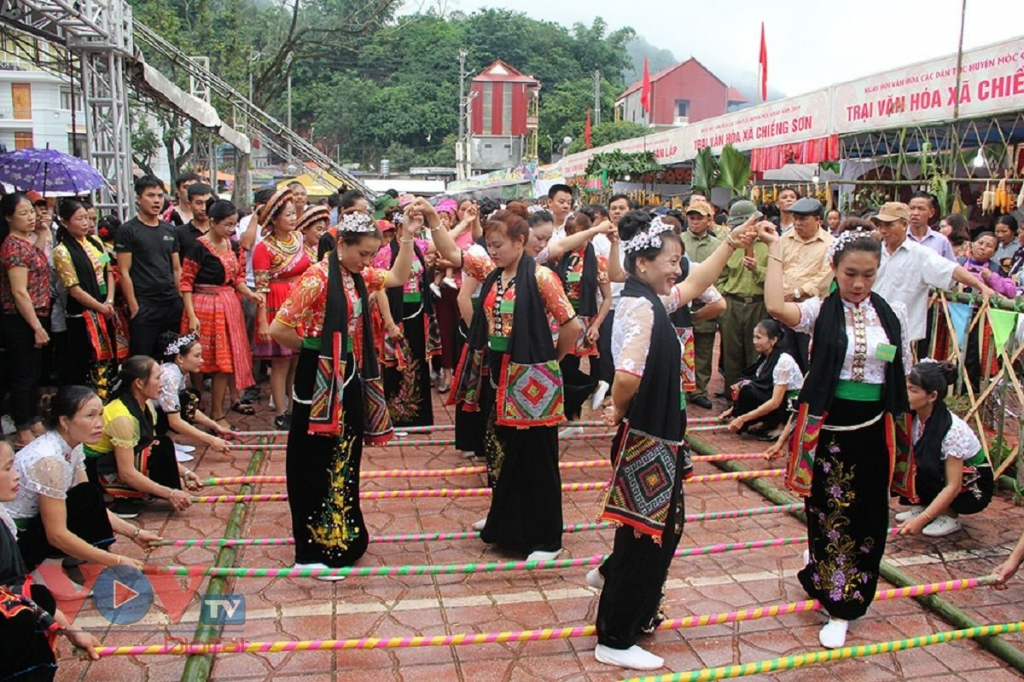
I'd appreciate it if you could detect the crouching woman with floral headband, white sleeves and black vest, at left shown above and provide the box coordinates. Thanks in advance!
[157,329,233,450]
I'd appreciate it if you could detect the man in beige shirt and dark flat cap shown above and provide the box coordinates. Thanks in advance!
[780,198,833,367]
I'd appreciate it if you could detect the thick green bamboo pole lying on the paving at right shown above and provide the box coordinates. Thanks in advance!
[687,435,1024,673]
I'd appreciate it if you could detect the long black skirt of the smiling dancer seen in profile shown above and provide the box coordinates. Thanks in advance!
[597,424,686,649]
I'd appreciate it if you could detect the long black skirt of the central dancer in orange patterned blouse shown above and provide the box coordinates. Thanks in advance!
[480,353,562,554]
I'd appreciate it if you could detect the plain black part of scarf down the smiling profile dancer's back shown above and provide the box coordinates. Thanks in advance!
[623,276,683,442]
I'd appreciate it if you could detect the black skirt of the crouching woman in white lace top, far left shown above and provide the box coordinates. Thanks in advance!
[17,481,114,570]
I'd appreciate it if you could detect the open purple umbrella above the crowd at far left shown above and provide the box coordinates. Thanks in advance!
[0,146,106,196]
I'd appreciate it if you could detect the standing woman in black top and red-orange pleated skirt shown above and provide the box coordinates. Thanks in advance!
[184,199,264,421]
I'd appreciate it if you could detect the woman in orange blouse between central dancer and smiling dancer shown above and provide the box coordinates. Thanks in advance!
[555,213,611,422]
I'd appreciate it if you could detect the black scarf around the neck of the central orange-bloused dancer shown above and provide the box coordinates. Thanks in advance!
[467,254,558,365]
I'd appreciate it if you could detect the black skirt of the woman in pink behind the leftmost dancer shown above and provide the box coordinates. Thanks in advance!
[384,301,434,427]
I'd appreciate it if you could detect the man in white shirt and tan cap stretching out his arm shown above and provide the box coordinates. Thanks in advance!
[871,202,993,342]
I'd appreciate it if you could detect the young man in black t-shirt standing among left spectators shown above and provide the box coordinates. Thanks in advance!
[115,175,183,359]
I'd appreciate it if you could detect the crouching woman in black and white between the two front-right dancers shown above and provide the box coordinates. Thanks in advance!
[719,317,804,441]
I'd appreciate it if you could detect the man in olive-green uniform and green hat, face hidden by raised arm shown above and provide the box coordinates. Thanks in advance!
[715,200,768,394]
